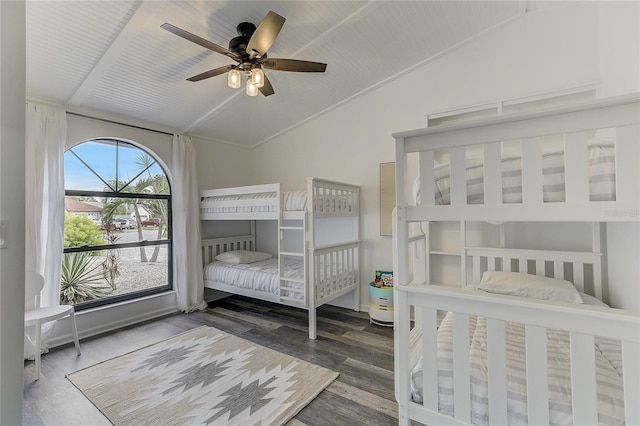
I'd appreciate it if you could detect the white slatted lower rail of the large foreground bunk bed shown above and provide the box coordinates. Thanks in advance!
[396,280,640,425]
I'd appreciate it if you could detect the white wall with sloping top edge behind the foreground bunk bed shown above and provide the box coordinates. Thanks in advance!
[246,2,640,309]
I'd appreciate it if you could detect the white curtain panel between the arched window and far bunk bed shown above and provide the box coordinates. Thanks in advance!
[171,135,207,312]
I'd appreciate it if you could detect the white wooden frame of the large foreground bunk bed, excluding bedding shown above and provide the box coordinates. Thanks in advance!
[393,95,640,424]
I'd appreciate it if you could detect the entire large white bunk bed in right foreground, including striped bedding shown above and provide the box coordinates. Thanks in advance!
[393,95,640,425]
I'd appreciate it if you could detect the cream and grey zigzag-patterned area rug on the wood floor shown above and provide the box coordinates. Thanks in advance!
[67,326,338,425]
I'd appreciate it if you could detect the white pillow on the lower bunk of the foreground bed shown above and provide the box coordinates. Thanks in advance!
[478,271,582,303]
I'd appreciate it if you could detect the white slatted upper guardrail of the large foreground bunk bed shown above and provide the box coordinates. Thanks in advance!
[393,95,640,222]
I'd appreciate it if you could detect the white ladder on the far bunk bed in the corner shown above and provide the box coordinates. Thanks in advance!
[278,212,307,306]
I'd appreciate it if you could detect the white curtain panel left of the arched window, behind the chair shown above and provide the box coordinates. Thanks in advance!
[24,103,67,358]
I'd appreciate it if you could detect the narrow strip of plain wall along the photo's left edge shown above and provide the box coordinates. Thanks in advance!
[0,1,25,425]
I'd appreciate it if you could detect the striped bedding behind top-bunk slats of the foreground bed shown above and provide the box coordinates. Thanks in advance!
[413,143,615,205]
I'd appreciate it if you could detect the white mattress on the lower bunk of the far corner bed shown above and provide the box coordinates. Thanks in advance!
[204,258,304,299]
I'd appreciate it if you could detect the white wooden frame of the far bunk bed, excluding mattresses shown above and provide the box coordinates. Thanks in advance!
[201,178,360,339]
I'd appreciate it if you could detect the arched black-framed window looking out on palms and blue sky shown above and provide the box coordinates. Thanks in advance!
[60,139,172,310]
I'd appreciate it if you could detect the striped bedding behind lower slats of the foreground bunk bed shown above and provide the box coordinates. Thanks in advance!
[411,294,624,425]
